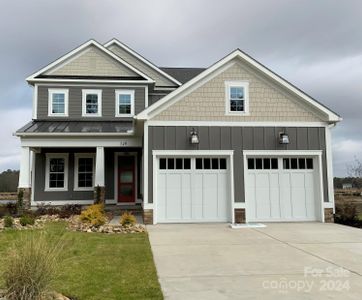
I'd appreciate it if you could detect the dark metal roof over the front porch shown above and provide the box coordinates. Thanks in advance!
[16,120,133,135]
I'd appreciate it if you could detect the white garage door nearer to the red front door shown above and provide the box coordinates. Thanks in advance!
[155,157,231,223]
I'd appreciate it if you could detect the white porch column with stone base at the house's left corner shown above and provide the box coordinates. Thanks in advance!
[18,147,31,208]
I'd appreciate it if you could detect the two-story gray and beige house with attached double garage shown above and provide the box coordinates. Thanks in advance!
[16,40,341,224]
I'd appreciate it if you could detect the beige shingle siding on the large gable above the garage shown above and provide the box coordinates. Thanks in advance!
[153,63,323,122]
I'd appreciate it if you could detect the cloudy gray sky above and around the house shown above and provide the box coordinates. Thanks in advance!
[0,0,362,176]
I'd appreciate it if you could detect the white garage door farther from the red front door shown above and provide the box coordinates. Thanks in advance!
[246,157,320,221]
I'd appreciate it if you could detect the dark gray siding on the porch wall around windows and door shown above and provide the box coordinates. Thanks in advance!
[34,148,142,202]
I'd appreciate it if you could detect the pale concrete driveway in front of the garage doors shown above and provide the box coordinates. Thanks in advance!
[148,223,362,300]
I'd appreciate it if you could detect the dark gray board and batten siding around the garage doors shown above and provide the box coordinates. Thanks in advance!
[148,126,328,203]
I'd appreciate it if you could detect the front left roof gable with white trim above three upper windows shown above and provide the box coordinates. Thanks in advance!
[27,40,154,82]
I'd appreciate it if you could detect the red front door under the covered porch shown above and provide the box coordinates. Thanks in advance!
[118,156,136,203]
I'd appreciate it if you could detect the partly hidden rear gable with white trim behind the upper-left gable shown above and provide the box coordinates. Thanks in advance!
[104,39,181,87]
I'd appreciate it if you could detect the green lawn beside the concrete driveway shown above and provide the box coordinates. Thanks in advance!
[0,223,163,300]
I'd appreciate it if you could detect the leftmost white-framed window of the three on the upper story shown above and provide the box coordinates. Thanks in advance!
[48,89,69,117]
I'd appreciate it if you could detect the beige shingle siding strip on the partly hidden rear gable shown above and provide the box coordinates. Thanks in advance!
[108,45,176,86]
